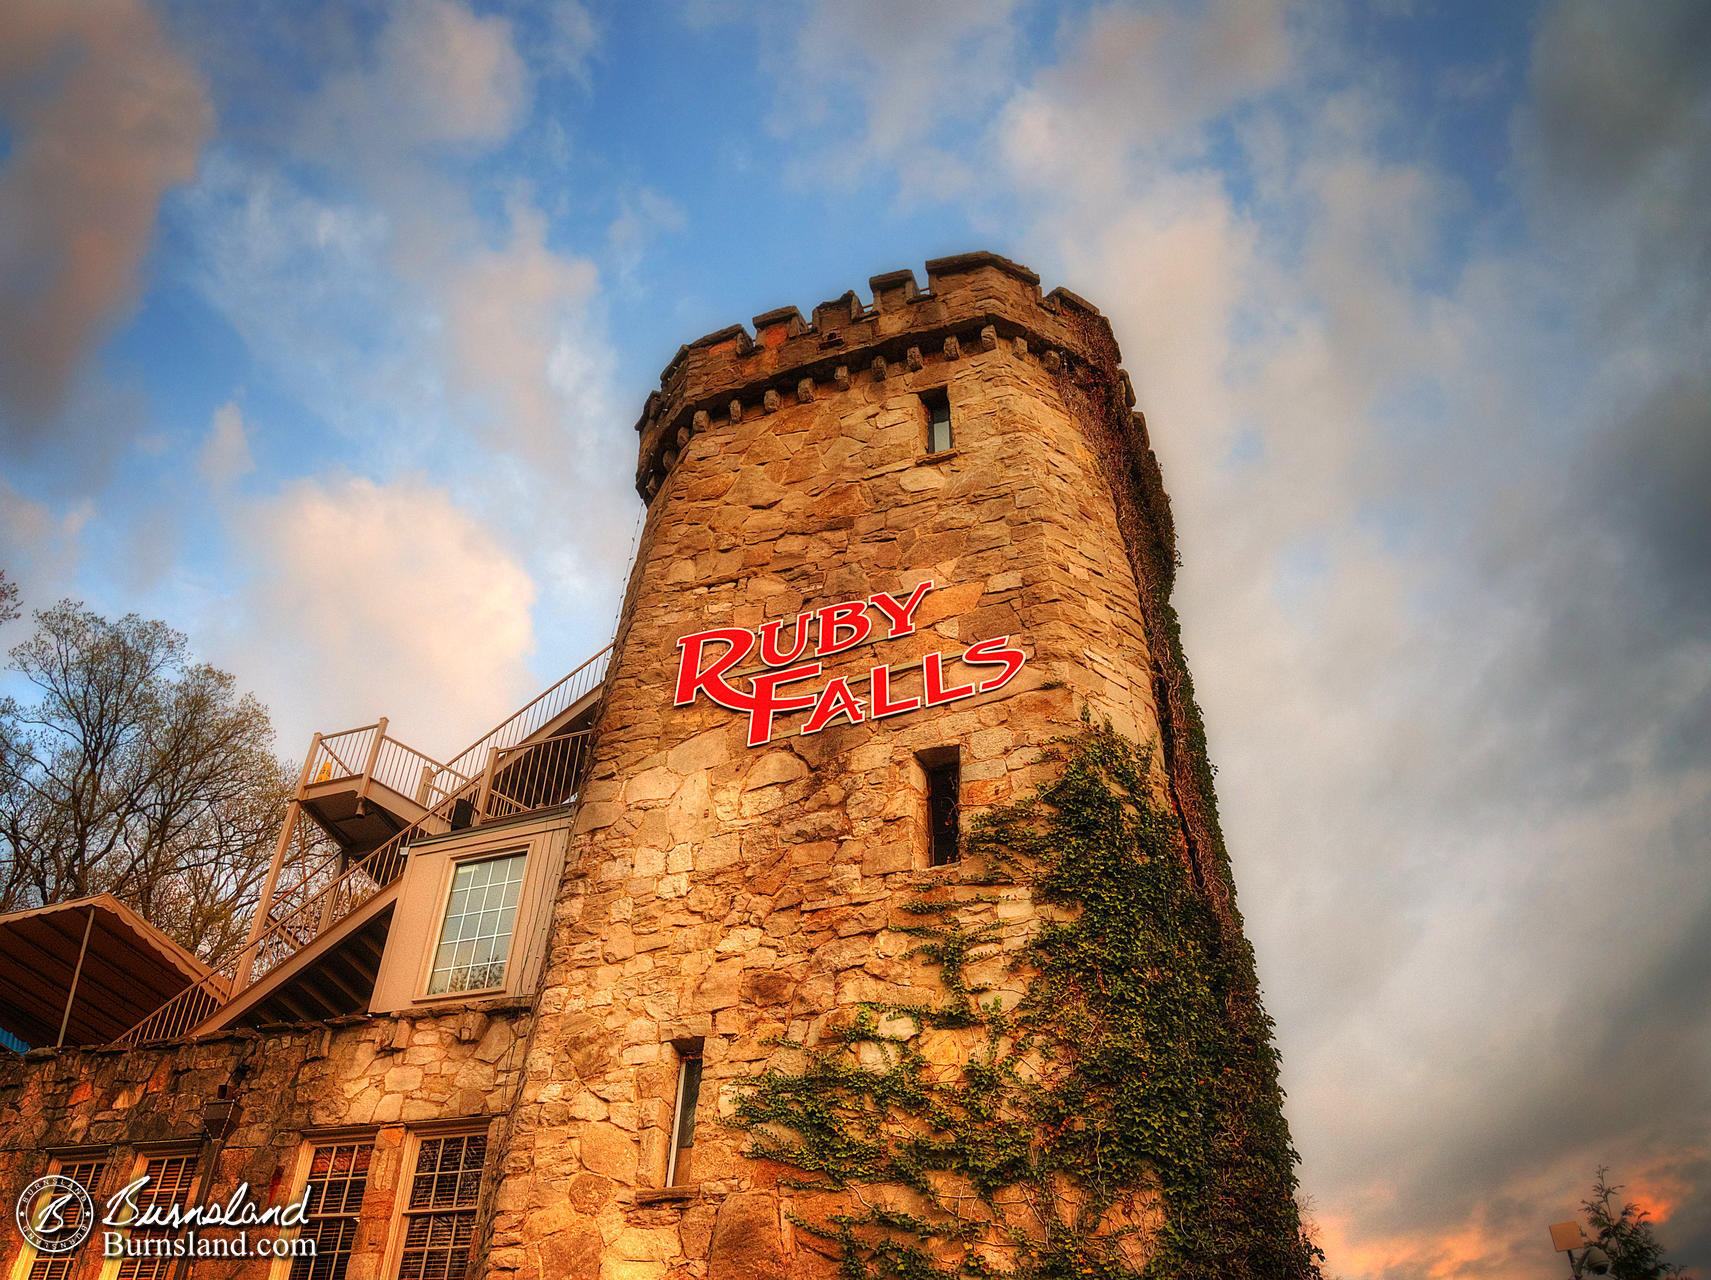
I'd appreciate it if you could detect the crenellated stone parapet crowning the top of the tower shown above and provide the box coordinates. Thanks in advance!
[636,252,1134,501]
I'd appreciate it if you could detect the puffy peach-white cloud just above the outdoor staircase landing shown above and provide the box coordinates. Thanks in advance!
[224,477,536,760]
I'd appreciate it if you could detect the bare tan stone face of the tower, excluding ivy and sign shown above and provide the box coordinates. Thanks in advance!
[486,255,1158,1280]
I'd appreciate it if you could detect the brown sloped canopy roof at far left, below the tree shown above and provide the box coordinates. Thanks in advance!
[0,893,219,1047]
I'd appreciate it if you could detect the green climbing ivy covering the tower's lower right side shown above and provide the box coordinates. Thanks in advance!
[731,717,1317,1280]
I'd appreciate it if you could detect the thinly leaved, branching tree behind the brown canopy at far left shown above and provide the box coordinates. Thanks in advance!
[0,588,294,963]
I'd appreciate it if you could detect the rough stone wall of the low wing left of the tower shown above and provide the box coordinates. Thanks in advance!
[0,1003,529,1280]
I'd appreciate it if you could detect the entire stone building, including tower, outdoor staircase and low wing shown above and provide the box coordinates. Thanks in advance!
[0,253,1312,1280]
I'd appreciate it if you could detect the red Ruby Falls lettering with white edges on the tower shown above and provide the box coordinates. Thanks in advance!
[674,582,1027,746]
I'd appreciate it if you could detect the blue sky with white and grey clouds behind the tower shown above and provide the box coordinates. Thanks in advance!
[0,0,1711,1280]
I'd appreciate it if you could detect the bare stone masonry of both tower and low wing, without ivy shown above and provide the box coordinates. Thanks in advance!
[0,253,1307,1280]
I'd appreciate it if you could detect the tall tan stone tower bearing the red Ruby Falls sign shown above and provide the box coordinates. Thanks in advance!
[481,253,1311,1280]
